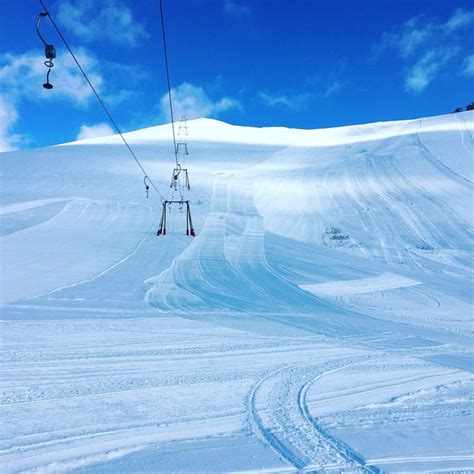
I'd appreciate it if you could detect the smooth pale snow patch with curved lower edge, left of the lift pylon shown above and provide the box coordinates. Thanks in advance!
[0,198,155,302]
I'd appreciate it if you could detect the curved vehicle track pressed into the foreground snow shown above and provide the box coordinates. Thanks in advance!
[247,355,380,472]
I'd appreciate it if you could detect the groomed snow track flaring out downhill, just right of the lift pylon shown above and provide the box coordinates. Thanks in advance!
[147,175,326,312]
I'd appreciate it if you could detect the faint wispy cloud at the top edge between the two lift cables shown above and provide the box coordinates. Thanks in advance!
[58,0,150,46]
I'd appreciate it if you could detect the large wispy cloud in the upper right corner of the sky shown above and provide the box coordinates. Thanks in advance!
[372,9,474,93]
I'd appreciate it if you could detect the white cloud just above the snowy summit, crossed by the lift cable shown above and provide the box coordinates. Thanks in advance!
[159,82,241,121]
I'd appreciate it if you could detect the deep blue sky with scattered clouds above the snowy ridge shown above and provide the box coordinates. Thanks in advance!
[0,0,474,151]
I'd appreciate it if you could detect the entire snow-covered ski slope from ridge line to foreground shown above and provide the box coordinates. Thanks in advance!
[0,112,474,473]
